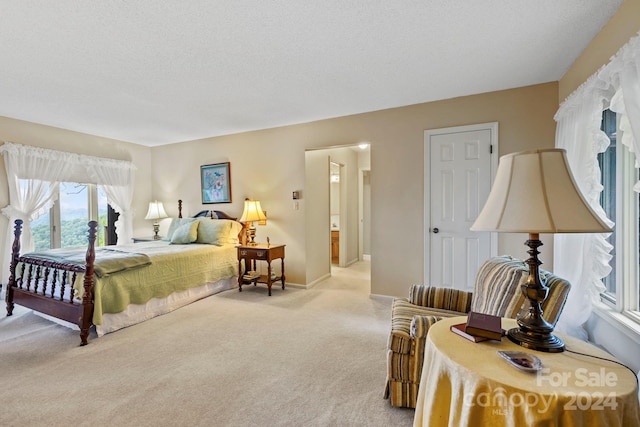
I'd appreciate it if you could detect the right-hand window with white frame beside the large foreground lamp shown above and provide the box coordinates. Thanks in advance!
[598,110,640,319]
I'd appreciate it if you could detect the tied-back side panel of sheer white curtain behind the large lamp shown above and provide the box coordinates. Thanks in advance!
[553,76,613,339]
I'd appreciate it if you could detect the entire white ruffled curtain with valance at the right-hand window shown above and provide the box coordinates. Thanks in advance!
[554,30,640,339]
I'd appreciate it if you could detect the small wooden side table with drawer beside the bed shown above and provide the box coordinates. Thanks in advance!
[238,243,285,296]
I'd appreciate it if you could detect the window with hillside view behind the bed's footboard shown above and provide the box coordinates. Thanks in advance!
[31,182,108,251]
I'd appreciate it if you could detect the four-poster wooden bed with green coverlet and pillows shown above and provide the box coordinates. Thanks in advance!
[6,201,243,345]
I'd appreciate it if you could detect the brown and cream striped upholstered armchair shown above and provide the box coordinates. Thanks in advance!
[384,256,570,408]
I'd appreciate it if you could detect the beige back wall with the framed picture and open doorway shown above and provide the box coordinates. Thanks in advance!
[151,83,558,295]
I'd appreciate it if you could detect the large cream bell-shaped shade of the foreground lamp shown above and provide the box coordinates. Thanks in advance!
[471,149,611,233]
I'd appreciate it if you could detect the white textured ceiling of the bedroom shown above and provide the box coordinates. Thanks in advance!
[0,0,622,146]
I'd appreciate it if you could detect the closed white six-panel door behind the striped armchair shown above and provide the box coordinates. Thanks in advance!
[425,124,497,291]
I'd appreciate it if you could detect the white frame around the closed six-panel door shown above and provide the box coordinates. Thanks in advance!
[422,122,499,284]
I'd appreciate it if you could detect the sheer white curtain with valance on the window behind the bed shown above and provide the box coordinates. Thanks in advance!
[0,142,135,283]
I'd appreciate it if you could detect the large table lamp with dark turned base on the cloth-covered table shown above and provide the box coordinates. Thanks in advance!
[471,149,611,353]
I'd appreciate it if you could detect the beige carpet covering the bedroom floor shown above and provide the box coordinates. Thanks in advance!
[0,262,414,426]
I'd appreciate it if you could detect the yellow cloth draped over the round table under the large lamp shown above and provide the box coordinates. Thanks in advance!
[414,317,640,427]
